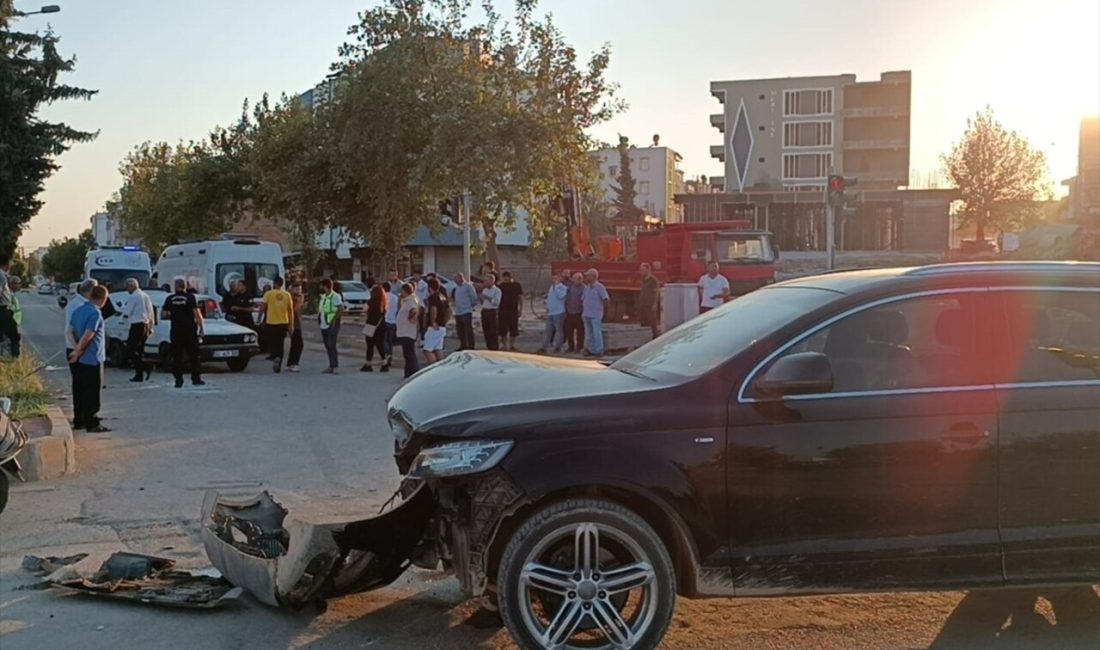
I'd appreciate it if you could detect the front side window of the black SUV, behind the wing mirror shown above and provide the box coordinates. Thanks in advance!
[765,294,991,393]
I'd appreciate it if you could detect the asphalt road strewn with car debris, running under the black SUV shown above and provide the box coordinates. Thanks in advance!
[0,294,1100,650]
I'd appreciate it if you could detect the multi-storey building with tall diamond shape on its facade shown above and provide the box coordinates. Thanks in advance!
[711,70,911,192]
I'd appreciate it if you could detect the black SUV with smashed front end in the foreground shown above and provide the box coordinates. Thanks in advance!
[204,263,1100,649]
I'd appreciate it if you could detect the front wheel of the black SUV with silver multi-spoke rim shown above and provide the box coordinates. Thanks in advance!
[497,499,677,650]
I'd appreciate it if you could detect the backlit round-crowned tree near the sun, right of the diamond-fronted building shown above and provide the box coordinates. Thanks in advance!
[943,107,1051,242]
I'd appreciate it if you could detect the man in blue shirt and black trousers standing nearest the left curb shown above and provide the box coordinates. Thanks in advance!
[68,286,110,433]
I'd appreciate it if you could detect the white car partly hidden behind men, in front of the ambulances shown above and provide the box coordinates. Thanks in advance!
[106,290,260,372]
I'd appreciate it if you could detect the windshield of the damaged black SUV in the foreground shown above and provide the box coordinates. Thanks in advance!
[611,287,836,378]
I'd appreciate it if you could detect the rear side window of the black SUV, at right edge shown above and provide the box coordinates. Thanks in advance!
[1002,290,1100,382]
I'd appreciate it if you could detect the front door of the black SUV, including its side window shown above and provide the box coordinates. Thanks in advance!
[727,288,1003,595]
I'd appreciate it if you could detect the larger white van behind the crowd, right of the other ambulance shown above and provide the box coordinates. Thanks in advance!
[155,239,286,298]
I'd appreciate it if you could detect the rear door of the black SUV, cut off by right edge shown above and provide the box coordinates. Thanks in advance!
[998,287,1100,584]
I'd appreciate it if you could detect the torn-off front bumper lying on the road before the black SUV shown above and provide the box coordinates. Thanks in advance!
[202,485,437,608]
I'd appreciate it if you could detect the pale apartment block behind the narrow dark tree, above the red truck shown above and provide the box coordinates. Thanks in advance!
[591,146,684,223]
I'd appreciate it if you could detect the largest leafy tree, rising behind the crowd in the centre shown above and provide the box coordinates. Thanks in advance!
[319,0,623,267]
